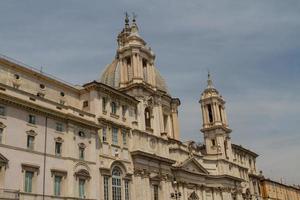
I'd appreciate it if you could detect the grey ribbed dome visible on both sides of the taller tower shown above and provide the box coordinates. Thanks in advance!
[99,59,169,94]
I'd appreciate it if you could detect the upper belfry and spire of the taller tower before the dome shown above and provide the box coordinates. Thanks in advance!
[116,14,157,88]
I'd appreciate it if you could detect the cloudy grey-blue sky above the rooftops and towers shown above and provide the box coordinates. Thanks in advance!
[0,0,300,184]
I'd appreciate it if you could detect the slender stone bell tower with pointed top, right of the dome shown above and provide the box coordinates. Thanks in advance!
[199,73,232,159]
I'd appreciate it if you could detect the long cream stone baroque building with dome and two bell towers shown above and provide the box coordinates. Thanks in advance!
[0,16,260,200]
